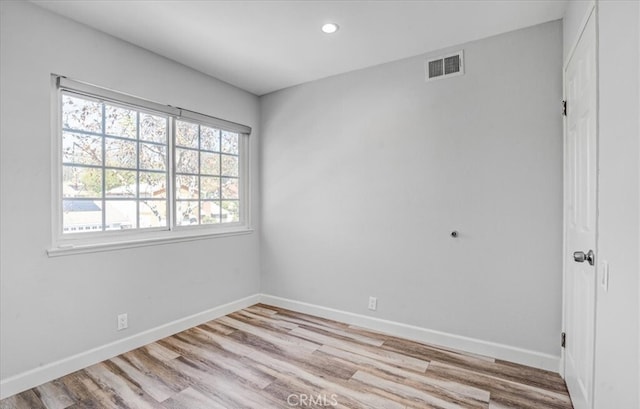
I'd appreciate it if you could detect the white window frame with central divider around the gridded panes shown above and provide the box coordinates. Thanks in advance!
[47,75,253,257]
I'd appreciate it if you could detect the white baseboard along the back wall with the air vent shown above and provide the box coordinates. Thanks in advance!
[260,294,560,372]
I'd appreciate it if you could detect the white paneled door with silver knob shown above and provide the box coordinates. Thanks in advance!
[564,6,597,409]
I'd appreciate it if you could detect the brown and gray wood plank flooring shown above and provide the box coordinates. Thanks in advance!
[0,304,572,409]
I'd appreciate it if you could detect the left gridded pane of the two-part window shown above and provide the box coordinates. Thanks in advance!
[61,91,169,234]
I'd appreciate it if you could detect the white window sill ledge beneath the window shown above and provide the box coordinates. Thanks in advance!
[47,228,254,257]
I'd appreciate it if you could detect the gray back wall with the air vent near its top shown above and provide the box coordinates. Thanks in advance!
[261,21,562,356]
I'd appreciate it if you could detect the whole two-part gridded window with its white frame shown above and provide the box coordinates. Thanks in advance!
[54,77,250,247]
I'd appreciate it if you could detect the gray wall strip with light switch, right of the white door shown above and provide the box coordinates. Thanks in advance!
[595,1,640,408]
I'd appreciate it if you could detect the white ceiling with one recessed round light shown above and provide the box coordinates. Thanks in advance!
[33,0,566,95]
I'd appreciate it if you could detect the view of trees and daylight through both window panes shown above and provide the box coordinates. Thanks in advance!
[61,91,240,233]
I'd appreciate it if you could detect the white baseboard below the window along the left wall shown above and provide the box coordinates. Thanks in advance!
[0,294,260,399]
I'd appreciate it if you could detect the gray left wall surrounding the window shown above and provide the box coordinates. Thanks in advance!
[0,1,260,379]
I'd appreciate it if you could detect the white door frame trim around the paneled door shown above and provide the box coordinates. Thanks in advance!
[559,0,600,388]
